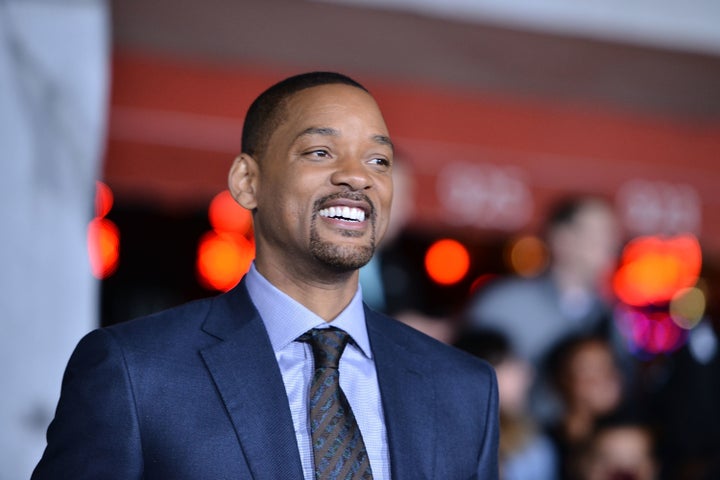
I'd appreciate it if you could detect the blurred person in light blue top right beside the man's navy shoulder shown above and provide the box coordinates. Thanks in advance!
[454,330,558,480]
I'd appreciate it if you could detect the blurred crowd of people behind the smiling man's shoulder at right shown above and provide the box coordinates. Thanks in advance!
[390,196,720,480]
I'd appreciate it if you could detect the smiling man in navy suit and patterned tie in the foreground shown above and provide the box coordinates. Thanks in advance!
[34,72,498,480]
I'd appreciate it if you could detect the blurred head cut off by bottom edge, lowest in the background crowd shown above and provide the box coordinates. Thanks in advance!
[579,421,660,480]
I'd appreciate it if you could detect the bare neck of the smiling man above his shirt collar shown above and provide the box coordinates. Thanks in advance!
[255,259,358,322]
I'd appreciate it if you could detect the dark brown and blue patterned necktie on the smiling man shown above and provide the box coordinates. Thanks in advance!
[298,327,372,480]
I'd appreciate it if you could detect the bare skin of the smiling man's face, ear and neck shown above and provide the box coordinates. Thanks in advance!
[229,84,393,321]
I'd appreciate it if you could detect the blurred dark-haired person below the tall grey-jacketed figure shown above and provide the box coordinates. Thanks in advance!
[547,335,625,480]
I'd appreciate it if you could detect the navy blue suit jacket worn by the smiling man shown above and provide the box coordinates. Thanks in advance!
[32,282,498,480]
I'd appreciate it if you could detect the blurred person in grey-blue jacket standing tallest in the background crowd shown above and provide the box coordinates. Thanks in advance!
[467,196,621,365]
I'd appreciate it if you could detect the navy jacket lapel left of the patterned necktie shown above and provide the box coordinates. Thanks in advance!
[201,283,303,480]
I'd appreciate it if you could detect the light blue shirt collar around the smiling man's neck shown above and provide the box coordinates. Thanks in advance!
[245,262,372,358]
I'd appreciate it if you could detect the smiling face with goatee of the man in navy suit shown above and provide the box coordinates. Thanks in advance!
[248,84,393,272]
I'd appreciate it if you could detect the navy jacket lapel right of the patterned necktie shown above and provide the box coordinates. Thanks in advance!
[365,308,437,480]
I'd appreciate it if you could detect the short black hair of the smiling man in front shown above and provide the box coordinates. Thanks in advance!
[241,72,369,157]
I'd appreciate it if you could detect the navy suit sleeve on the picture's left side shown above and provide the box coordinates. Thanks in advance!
[32,330,143,480]
